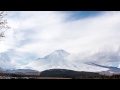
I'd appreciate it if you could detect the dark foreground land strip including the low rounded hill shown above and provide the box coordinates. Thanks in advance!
[0,69,120,79]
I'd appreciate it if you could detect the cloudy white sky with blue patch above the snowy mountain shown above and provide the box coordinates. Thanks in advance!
[0,11,120,67]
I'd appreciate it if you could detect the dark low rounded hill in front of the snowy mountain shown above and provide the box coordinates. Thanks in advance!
[40,69,99,77]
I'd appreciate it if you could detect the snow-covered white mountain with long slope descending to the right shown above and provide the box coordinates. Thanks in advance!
[26,50,108,72]
